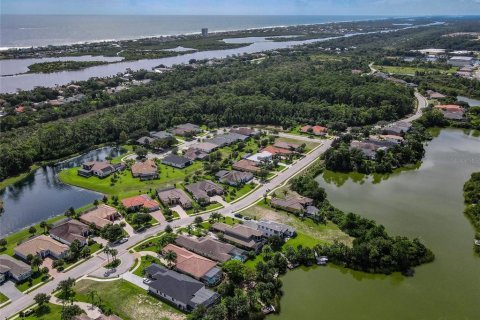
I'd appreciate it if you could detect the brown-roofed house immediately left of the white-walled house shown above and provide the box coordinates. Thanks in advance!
[212,222,263,251]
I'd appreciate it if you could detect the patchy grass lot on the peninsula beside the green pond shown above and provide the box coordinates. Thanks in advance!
[241,201,353,246]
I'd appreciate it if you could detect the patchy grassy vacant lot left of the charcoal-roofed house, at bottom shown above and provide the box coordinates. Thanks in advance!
[75,280,185,320]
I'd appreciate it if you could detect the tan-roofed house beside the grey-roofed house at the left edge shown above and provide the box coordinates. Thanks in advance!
[15,234,69,260]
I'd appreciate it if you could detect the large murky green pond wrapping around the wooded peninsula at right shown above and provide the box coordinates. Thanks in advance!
[271,129,480,320]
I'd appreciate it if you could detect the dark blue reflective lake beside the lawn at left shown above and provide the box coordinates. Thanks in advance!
[0,147,125,237]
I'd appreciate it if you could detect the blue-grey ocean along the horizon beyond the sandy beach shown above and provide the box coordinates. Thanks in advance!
[0,15,384,49]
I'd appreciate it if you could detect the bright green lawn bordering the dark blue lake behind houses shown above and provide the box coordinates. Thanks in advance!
[58,161,203,198]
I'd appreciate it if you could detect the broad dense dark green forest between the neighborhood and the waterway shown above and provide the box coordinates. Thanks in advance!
[0,54,413,179]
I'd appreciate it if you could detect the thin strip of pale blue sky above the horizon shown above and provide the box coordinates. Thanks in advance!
[0,0,480,16]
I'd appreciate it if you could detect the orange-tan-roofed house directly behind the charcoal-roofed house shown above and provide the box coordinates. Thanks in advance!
[162,243,222,285]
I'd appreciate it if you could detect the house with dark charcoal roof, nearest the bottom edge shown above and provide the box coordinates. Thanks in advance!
[145,263,220,311]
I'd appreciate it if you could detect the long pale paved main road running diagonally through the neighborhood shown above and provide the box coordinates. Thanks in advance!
[1,140,332,318]
